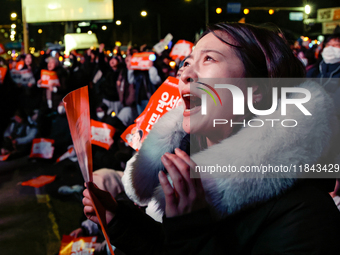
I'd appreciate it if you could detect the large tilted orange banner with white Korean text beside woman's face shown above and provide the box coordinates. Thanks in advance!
[121,77,181,151]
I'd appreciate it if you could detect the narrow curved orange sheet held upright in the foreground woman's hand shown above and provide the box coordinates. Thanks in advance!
[63,86,117,255]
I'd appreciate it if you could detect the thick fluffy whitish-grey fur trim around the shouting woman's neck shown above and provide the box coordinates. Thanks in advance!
[122,81,339,217]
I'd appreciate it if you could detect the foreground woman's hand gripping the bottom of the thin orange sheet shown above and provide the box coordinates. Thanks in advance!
[83,184,117,224]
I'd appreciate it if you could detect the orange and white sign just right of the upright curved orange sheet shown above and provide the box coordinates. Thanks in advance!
[91,120,116,150]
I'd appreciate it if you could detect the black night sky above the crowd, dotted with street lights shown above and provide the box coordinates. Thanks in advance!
[0,0,340,48]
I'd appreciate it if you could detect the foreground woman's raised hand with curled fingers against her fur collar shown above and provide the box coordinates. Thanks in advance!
[158,148,208,218]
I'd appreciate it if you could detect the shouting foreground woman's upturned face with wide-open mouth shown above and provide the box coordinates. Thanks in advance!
[179,31,247,140]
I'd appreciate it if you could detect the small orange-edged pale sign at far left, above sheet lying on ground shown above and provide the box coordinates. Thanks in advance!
[30,138,54,159]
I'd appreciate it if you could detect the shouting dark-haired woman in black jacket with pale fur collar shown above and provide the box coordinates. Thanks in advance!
[83,23,340,254]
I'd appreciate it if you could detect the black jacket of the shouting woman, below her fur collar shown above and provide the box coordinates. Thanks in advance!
[109,182,340,255]
